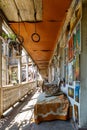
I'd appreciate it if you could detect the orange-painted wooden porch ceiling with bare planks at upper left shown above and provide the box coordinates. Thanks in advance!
[0,0,72,69]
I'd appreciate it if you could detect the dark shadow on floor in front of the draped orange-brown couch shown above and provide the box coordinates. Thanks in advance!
[22,120,75,130]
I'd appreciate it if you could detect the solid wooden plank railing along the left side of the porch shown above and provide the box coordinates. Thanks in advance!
[0,82,37,116]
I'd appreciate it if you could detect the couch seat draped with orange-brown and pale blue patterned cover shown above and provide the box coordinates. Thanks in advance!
[34,93,69,123]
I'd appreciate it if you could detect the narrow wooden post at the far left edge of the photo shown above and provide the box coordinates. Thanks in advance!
[0,17,3,116]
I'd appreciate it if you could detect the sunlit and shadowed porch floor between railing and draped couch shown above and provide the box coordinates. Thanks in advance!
[0,91,77,130]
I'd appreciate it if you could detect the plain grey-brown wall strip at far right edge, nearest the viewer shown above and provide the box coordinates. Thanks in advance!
[79,2,87,127]
